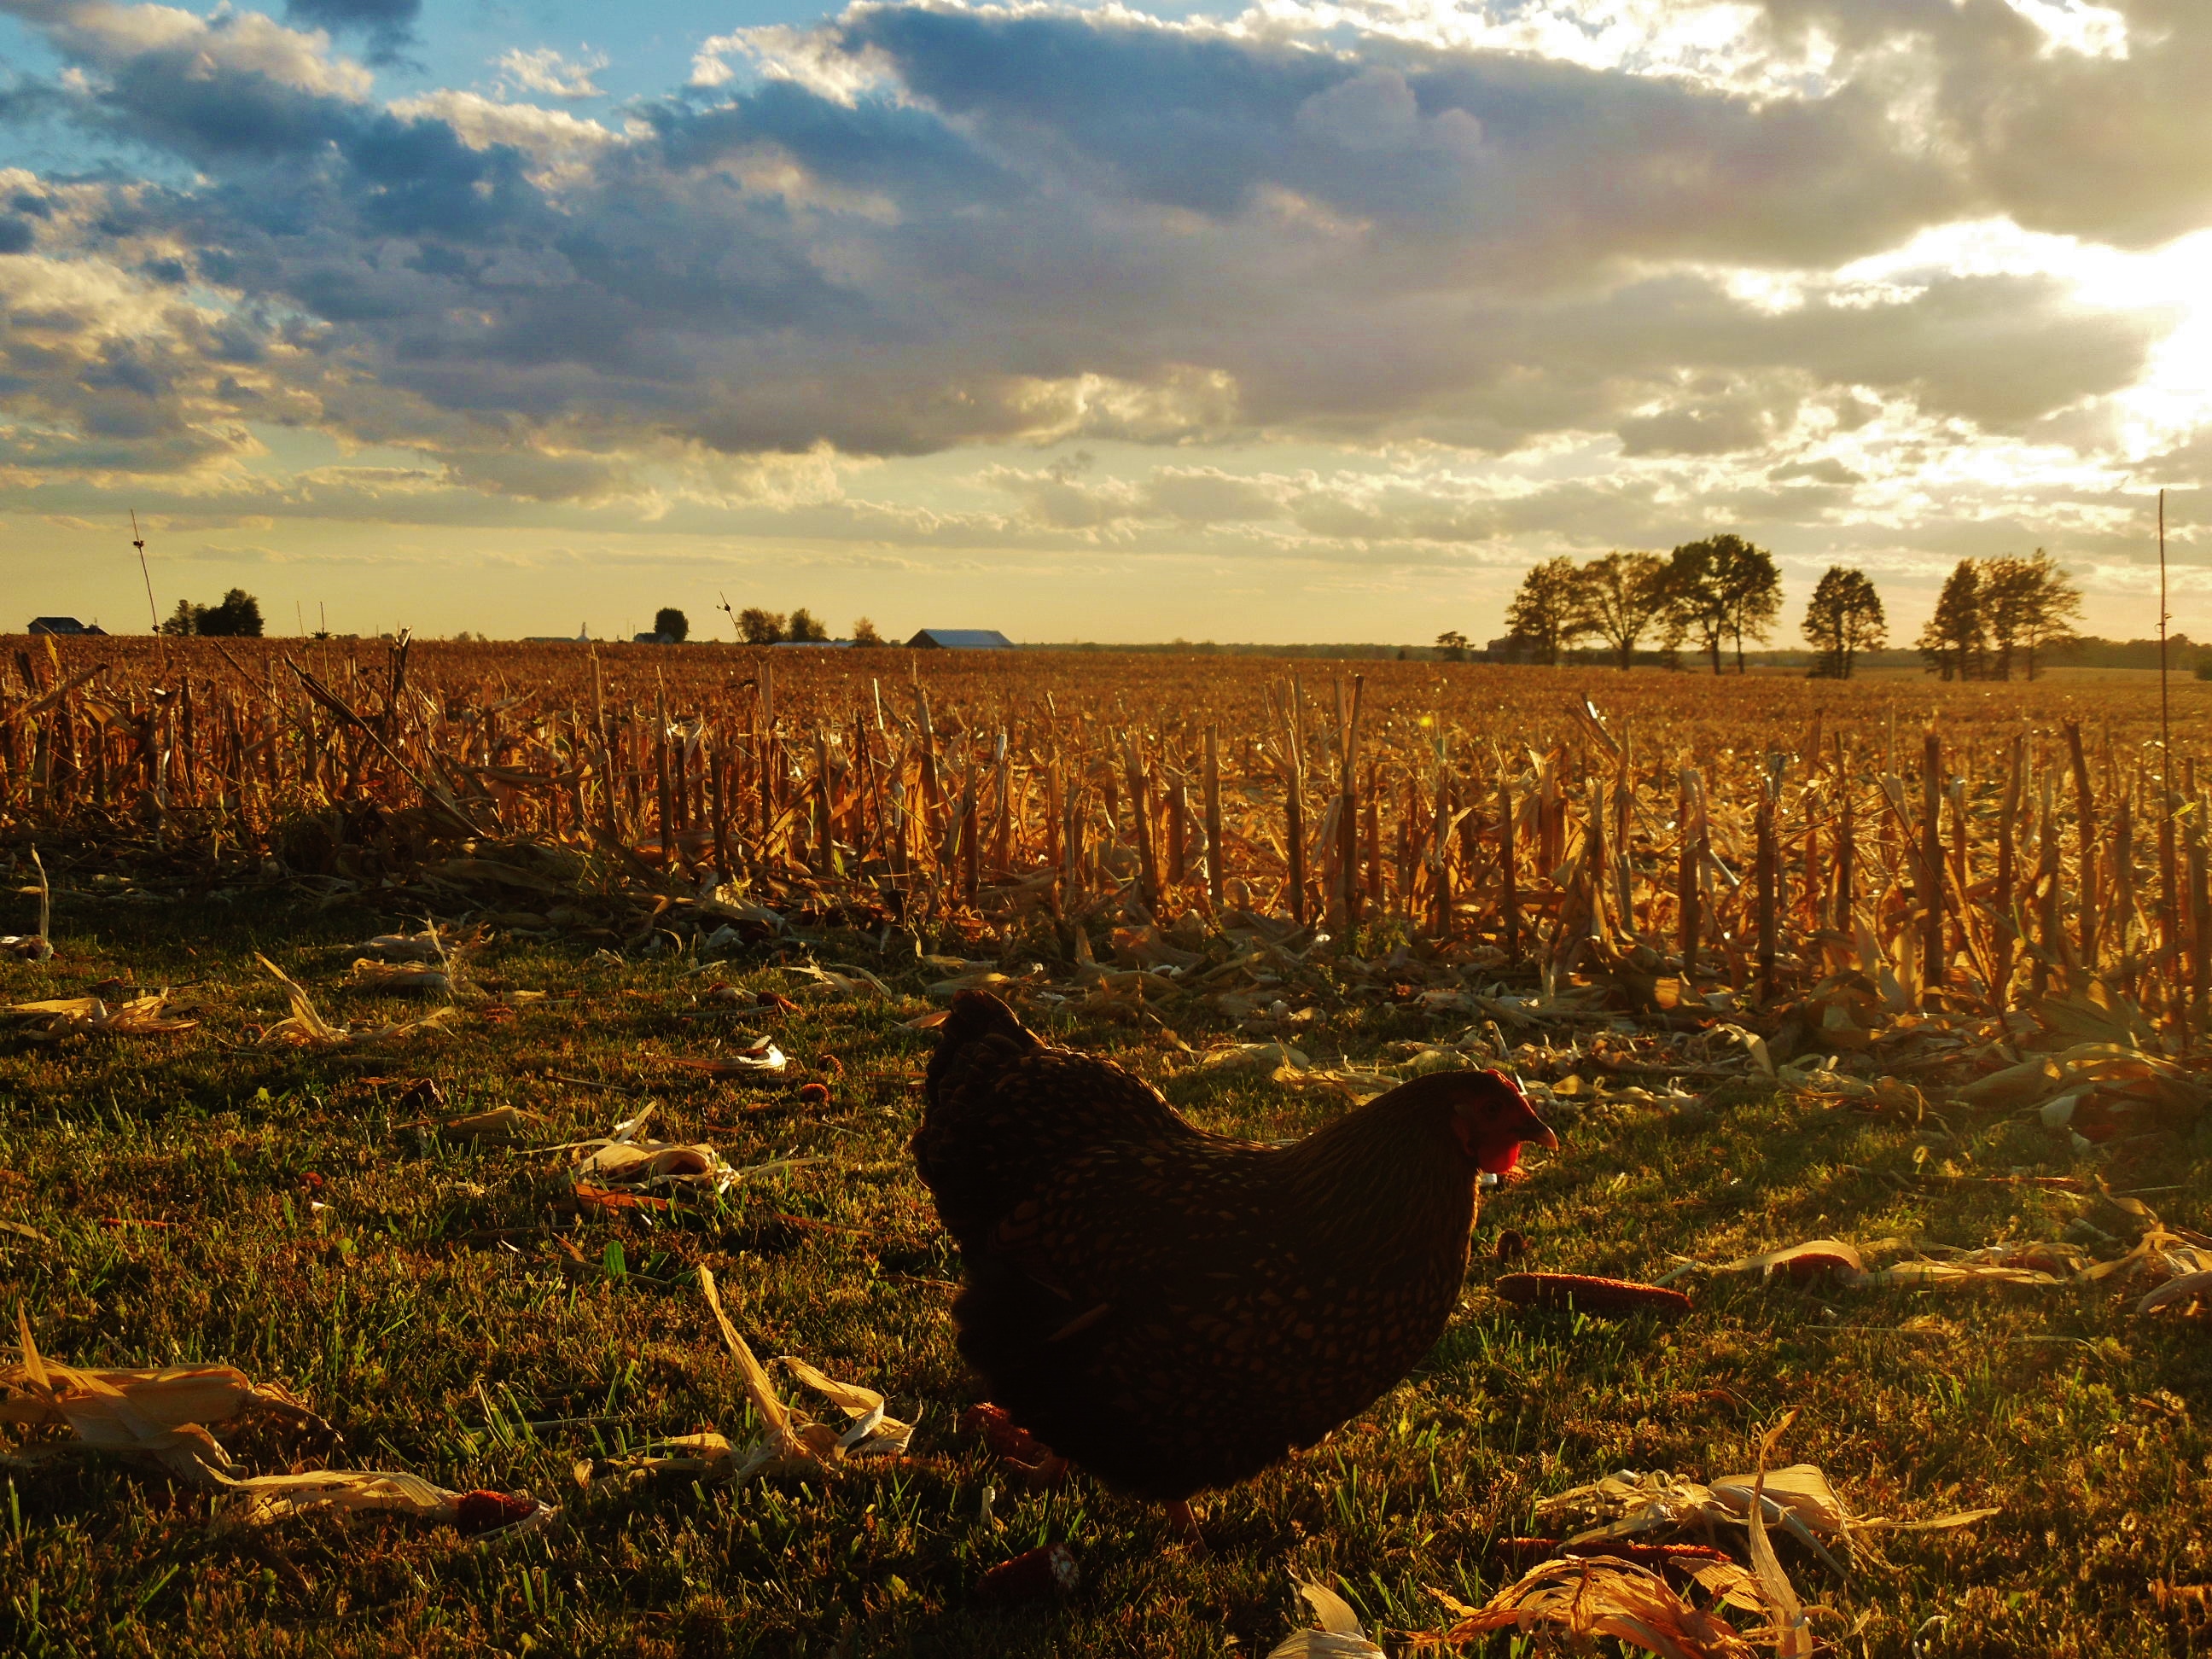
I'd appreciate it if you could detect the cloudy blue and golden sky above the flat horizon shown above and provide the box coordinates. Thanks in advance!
[0,0,2212,643]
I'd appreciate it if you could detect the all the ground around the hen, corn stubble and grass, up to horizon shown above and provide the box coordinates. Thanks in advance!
[0,639,2212,1655]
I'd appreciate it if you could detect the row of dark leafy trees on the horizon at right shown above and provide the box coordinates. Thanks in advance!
[1477,535,2081,679]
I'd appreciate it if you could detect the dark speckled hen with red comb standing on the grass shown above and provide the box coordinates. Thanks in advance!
[911,991,1557,1524]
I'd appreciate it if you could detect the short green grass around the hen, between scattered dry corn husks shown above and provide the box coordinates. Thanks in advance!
[0,896,2212,1659]
